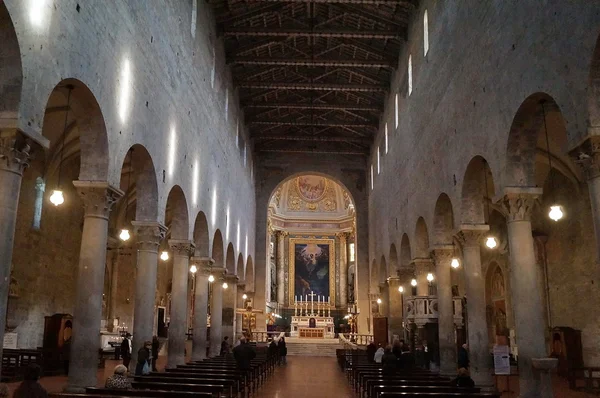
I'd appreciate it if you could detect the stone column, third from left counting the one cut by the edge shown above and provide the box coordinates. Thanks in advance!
[130,221,167,368]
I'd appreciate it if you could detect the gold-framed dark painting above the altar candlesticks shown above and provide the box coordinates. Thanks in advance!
[288,238,335,306]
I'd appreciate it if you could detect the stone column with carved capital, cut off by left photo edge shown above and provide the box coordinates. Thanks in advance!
[0,130,30,380]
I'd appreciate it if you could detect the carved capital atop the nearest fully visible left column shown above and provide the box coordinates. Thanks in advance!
[73,180,124,220]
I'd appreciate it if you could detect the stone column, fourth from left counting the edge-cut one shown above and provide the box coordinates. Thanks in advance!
[166,239,194,368]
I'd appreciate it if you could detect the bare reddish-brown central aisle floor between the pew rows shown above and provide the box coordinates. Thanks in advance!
[256,356,354,398]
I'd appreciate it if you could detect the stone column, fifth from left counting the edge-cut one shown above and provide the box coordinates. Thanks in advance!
[192,257,215,361]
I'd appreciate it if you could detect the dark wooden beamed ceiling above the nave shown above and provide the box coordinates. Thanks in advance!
[209,0,418,155]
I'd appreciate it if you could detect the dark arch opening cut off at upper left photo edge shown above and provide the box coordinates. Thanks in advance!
[0,2,23,127]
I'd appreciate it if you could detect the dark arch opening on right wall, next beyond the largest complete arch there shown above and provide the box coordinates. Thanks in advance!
[460,155,496,224]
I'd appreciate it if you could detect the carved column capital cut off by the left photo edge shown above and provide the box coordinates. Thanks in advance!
[0,129,32,175]
